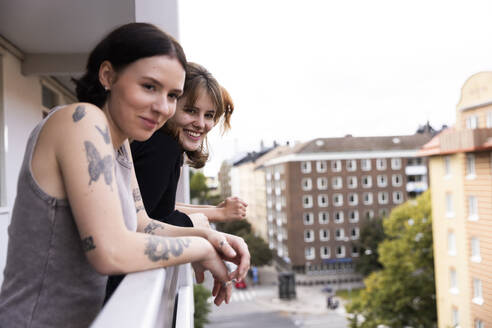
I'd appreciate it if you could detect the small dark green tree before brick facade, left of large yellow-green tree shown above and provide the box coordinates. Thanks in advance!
[353,218,386,277]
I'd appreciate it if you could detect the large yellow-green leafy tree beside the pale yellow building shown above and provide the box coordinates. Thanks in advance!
[348,191,437,328]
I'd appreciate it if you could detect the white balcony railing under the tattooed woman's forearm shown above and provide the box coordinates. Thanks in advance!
[91,264,195,328]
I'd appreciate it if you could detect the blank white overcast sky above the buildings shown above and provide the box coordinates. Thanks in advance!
[179,0,492,175]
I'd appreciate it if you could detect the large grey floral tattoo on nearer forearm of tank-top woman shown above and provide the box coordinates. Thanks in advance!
[145,236,191,262]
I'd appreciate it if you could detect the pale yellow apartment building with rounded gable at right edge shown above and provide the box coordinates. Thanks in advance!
[420,72,492,328]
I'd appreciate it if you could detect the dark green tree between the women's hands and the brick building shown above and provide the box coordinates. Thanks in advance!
[217,220,273,266]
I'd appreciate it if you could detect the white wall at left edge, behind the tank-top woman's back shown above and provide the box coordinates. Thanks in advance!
[0,51,42,284]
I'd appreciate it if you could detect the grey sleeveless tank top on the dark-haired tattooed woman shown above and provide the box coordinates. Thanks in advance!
[0,108,137,328]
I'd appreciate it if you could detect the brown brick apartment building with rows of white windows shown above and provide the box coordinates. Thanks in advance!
[264,133,432,280]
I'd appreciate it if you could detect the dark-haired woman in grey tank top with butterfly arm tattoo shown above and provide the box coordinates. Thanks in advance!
[0,23,249,328]
